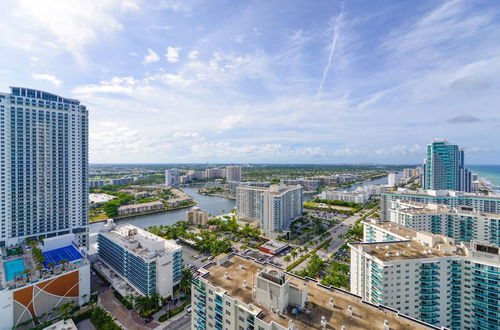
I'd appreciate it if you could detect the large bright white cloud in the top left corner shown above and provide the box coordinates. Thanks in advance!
[6,0,139,62]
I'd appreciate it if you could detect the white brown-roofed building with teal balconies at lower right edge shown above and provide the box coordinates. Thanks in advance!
[349,222,500,330]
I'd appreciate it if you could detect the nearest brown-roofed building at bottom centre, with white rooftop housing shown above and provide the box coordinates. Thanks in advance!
[191,254,439,330]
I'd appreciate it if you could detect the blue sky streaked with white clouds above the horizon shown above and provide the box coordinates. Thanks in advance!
[0,0,500,164]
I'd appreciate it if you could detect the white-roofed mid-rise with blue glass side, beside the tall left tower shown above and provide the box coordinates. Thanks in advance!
[97,220,183,297]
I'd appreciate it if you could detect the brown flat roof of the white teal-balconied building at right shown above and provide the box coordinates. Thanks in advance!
[350,241,462,261]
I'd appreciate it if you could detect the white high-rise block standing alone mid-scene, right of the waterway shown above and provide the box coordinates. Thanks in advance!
[236,184,303,237]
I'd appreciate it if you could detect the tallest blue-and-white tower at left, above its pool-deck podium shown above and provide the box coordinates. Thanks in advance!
[0,87,88,247]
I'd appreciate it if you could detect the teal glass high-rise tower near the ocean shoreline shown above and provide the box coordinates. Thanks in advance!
[424,139,472,192]
